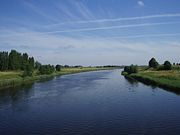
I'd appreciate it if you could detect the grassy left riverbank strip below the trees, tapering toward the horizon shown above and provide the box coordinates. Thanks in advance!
[0,67,114,89]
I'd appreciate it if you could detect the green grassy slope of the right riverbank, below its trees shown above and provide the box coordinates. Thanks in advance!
[123,66,180,90]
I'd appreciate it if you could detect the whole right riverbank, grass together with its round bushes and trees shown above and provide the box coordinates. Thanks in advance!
[122,58,180,90]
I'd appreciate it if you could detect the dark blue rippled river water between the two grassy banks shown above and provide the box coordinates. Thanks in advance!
[0,70,180,135]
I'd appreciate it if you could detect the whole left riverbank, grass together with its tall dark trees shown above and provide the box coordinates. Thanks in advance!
[0,50,119,89]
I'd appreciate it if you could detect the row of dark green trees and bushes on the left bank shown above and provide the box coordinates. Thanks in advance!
[0,50,61,77]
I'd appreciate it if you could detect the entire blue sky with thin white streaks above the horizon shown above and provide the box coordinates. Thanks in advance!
[0,0,180,65]
